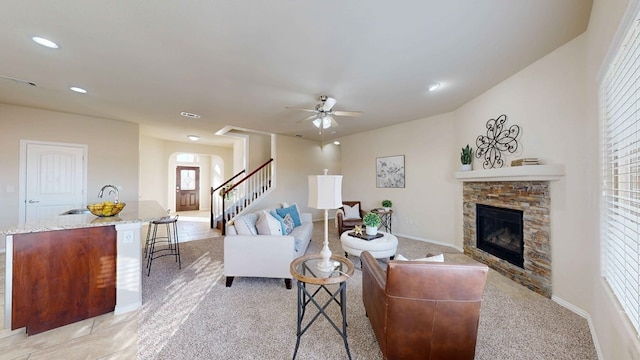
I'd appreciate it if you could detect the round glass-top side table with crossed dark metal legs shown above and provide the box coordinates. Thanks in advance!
[290,254,354,359]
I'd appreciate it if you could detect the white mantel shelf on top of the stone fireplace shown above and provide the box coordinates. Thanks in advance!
[455,165,564,182]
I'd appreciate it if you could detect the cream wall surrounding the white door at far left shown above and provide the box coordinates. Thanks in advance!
[0,104,138,227]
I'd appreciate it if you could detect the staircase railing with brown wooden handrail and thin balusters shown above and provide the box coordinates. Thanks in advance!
[210,159,273,235]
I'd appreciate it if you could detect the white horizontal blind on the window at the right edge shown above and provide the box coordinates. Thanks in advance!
[601,15,640,333]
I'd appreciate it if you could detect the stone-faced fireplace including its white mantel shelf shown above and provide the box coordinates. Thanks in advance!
[456,165,564,298]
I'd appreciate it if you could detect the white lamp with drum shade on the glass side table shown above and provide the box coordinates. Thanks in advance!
[309,169,342,272]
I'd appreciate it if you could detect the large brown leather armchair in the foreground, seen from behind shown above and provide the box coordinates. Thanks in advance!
[360,251,488,360]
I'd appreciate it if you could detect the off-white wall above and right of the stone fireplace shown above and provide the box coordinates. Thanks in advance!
[455,35,599,309]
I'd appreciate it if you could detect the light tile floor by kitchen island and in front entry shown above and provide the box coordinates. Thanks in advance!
[0,211,220,360]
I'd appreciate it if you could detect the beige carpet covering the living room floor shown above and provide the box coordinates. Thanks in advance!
[138,223,597,360]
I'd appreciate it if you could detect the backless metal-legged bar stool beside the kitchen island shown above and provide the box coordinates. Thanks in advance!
[144,215,182,276]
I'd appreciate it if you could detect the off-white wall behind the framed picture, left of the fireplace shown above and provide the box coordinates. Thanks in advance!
[340,113,462,243]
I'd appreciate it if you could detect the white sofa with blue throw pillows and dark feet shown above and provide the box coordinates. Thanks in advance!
[224,207,313,289]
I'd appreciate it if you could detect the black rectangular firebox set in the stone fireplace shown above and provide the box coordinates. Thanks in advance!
[476,204,524,268]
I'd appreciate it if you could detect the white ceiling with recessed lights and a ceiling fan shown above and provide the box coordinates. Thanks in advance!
[0,0,592,143]
